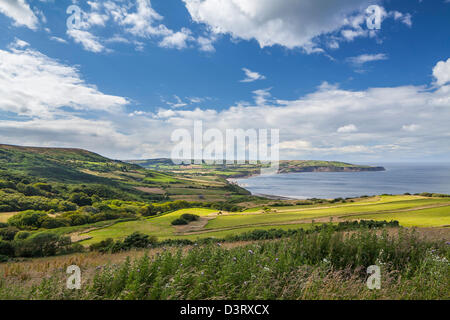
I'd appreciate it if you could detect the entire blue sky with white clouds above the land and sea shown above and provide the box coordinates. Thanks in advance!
[0,0,450,164]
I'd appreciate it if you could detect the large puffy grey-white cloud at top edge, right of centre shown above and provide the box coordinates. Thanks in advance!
[183,0,412,53]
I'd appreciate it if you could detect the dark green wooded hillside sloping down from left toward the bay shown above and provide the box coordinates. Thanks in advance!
[0,144,253,201]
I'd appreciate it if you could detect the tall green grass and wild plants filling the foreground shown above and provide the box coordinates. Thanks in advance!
[0,229,450,299]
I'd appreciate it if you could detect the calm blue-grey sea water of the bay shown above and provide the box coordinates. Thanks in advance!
[236,163,450,199]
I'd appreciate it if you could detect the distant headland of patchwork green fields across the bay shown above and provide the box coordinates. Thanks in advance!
[126,158,385,178]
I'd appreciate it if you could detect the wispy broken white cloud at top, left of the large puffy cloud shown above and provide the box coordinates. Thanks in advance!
[67,0,211,52]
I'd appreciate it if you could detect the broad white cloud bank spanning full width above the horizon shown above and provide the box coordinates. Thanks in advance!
[0,42,450,161]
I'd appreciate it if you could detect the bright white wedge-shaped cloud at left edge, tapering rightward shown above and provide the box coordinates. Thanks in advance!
[0,41,128,117]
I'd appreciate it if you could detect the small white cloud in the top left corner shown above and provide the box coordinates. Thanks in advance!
[0,0,39,30]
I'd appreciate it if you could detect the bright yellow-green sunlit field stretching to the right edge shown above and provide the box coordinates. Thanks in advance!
[82,196,450,245]
